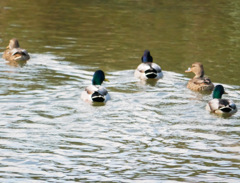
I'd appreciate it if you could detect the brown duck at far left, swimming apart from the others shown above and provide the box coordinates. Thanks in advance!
[3,38,30,61]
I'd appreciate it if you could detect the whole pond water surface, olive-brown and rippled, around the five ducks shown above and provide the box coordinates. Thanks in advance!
[0,1,240,183]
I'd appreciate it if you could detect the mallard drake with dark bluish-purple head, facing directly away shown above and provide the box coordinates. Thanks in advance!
[134,50,163,80]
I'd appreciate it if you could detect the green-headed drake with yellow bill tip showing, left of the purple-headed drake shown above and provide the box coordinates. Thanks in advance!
[81,70,110,102]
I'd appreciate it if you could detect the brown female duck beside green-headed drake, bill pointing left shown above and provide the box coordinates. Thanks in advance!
[185,62,214,92]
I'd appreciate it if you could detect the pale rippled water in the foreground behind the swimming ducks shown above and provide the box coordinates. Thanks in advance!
[0,54,240,182]
